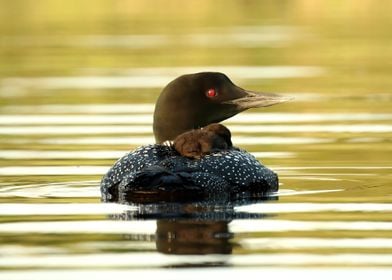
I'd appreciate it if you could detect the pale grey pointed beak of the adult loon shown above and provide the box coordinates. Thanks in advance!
[222,88,293,111]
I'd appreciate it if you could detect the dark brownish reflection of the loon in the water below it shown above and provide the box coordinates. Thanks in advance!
[110,197,277,258]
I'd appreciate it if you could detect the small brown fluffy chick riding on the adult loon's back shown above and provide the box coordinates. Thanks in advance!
[173,123,233,159]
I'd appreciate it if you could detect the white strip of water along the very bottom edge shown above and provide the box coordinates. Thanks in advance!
[1,268,392,280]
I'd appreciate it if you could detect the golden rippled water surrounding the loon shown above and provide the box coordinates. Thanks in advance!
[0,0,392,279]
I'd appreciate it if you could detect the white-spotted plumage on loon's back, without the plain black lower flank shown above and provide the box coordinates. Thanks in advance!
[101,144,278,201]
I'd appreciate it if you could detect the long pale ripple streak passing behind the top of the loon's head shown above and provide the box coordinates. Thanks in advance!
[1,66,324,89]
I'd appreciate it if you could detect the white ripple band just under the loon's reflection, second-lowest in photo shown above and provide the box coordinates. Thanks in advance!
[0,253,392,268]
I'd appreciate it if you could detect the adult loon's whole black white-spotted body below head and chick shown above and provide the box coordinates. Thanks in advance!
[101,144,278,202]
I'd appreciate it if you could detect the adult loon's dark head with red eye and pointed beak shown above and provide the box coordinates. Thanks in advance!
[153,72,290,143]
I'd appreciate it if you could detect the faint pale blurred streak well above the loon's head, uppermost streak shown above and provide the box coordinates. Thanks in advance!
[0,25,305,50]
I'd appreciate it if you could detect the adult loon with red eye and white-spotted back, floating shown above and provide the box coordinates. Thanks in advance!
[101,72,290,202]
